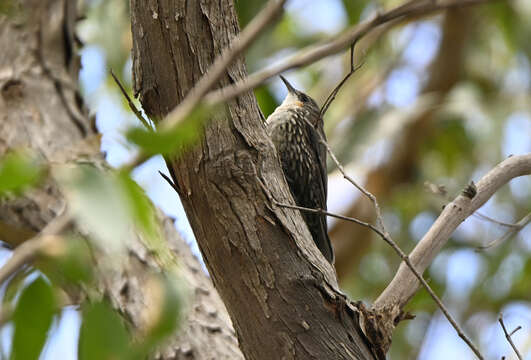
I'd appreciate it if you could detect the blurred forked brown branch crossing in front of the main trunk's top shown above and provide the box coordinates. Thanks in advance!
[124,0,492,173]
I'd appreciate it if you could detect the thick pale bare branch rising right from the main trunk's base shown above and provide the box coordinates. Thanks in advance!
[375,154,531,308]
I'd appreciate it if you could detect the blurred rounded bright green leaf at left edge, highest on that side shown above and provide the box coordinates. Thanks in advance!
[0,152,43,196]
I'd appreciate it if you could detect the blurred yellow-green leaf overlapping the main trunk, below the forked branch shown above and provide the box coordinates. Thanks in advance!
[127,106,213,155]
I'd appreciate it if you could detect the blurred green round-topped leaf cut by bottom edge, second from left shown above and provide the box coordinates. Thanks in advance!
[78,302,129,360]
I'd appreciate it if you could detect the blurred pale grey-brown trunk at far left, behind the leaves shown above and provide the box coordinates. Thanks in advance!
[0,0,243,359]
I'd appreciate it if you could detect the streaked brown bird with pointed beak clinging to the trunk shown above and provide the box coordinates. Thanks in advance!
[266,75,334,264]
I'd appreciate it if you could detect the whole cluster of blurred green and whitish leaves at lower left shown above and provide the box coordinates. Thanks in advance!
[0,151,183,360]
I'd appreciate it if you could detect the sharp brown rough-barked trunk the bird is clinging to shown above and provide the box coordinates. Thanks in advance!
[131,0,372,360]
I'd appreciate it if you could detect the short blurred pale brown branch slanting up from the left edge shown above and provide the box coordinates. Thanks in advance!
[0,213,72,284]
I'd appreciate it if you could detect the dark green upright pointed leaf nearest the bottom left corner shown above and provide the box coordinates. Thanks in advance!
[11,277,57,360]
